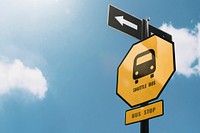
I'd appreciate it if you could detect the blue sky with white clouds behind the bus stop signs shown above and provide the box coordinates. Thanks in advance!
[0,0,200,133]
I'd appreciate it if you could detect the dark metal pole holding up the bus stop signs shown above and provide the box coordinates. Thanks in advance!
[140,18,150,133]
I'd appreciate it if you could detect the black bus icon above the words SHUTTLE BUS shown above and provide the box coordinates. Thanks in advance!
[133,49,156,84]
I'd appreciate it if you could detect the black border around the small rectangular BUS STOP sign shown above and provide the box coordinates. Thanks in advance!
[124,100,164,125]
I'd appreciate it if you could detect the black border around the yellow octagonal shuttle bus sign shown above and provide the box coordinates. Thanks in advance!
[116,35,176,107]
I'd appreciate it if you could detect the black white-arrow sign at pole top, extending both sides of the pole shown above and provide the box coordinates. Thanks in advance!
[108,5,172,42]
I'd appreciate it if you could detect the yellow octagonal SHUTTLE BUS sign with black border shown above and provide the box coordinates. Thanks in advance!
[117,35,175,106]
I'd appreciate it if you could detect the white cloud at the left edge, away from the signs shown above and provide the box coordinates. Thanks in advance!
[0,59,47,99]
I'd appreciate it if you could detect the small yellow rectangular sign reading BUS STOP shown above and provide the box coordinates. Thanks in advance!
[125,100,164,125]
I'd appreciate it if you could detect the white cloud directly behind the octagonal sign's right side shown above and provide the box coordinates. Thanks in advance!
[160,23,200,77]
